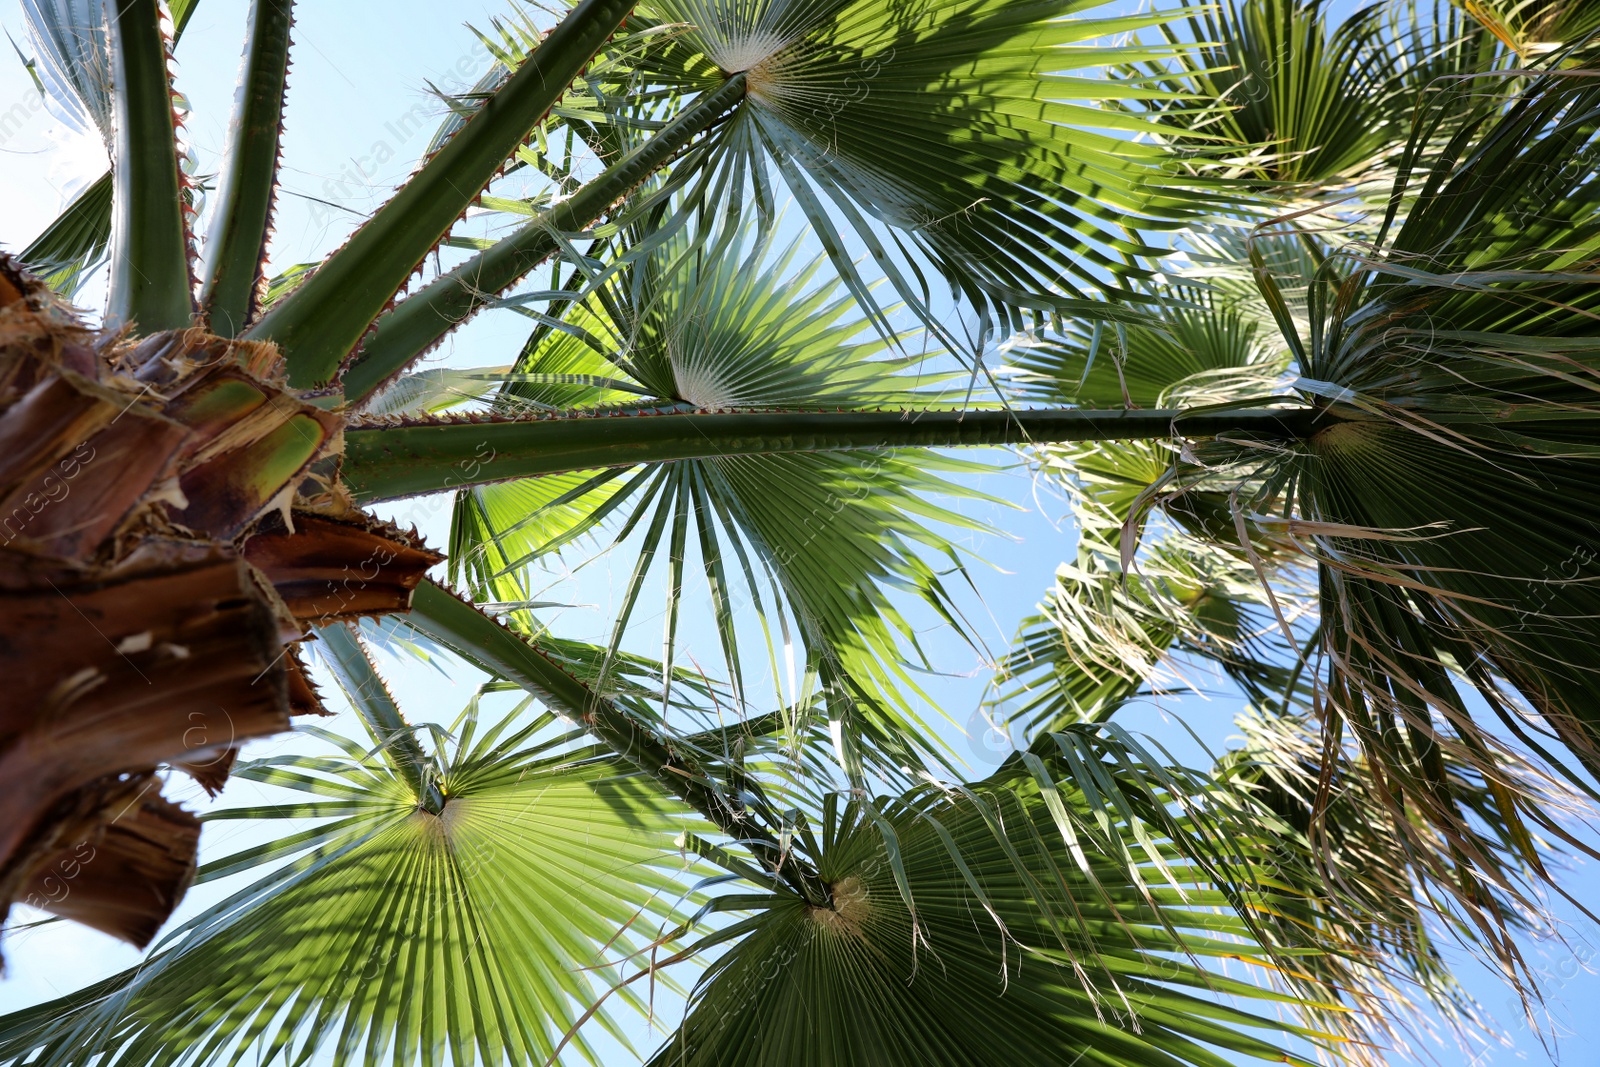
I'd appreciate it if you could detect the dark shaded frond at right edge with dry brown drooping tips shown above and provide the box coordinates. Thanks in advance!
[1088,66,1600,973]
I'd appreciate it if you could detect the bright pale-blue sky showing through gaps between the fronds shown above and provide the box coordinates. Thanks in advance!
[0,0,1600,1067]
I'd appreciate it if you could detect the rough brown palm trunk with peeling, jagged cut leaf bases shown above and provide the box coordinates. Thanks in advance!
[0,256,440,947]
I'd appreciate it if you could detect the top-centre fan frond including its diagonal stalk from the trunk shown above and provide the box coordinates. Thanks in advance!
[344,0,1218,391]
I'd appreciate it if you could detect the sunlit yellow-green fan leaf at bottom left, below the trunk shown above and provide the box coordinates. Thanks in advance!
[0,653,699,1067]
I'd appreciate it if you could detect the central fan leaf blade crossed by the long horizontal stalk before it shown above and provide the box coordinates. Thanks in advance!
[448,225,982,780]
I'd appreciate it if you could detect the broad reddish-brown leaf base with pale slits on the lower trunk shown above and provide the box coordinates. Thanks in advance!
[0,544,290,861]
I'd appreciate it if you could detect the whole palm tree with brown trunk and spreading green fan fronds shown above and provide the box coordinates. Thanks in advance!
[0,0,1600,1065]
